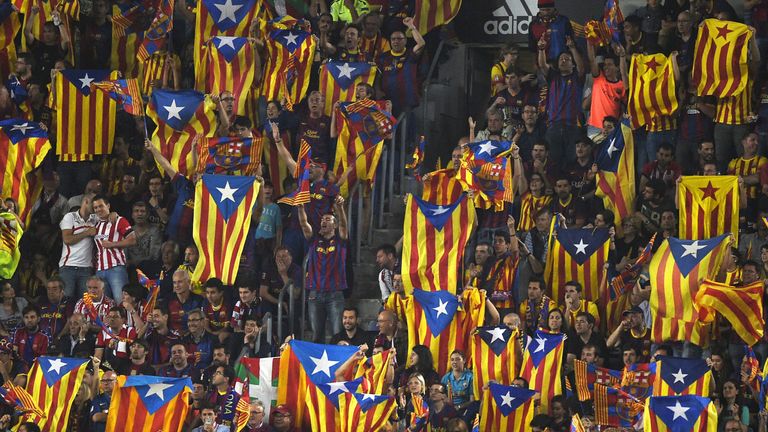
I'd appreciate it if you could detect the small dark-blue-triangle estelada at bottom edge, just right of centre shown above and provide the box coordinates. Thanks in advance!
[480,383,536,431]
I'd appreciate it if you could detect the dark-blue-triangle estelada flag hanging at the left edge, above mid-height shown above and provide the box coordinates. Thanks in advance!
[0,119,51,224]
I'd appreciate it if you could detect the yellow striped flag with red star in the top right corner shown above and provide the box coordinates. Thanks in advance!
[691,18,752,98]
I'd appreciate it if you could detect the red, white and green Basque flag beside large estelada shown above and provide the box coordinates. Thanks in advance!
[235,357,280,418]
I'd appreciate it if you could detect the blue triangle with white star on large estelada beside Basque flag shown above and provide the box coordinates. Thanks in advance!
[289,339,358,385]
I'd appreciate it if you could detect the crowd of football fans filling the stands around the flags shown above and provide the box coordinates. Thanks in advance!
[0,0,768,432]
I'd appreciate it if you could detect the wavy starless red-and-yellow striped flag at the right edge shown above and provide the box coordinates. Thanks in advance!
[693,279,765,346]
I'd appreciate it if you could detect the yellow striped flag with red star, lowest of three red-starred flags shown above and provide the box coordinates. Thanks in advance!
[677,176,740,242]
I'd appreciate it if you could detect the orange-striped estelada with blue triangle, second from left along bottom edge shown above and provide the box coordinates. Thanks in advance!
[107,375,192,432]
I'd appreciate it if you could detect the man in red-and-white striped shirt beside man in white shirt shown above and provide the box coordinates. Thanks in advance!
[93,195,136,301]
